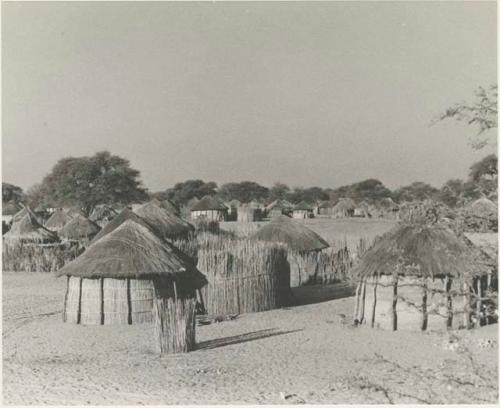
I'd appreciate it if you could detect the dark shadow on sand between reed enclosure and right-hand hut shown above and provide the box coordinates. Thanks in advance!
[291,283,355,306]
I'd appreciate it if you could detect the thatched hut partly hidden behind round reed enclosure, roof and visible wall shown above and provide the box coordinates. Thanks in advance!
[251,215,329,287]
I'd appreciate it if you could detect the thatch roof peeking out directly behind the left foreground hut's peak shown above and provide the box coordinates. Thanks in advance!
[135,202,194,239]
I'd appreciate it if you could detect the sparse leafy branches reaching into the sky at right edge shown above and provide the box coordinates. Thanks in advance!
[434,84,498,150]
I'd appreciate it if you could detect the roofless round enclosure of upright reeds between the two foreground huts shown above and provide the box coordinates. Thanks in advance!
[198,236,290,316]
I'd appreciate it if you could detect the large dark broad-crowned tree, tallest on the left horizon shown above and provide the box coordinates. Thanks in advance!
[36,151,148,214]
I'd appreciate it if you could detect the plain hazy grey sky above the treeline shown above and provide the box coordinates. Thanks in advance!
[2,2,497,191]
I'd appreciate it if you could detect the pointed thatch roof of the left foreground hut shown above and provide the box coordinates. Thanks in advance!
[56,220,207,289]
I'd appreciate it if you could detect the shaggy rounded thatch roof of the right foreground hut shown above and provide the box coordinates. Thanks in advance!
[353,224,486,277]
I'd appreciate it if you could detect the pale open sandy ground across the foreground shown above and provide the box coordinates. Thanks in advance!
[3,272,498,405]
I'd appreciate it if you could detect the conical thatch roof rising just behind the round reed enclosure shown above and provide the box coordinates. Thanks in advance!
[252,215,329,252]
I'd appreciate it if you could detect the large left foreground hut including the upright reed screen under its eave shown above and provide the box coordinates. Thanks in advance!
[57,220,207,353]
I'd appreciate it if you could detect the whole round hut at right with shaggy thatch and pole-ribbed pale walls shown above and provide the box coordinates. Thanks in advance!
[353,223,489,330]
